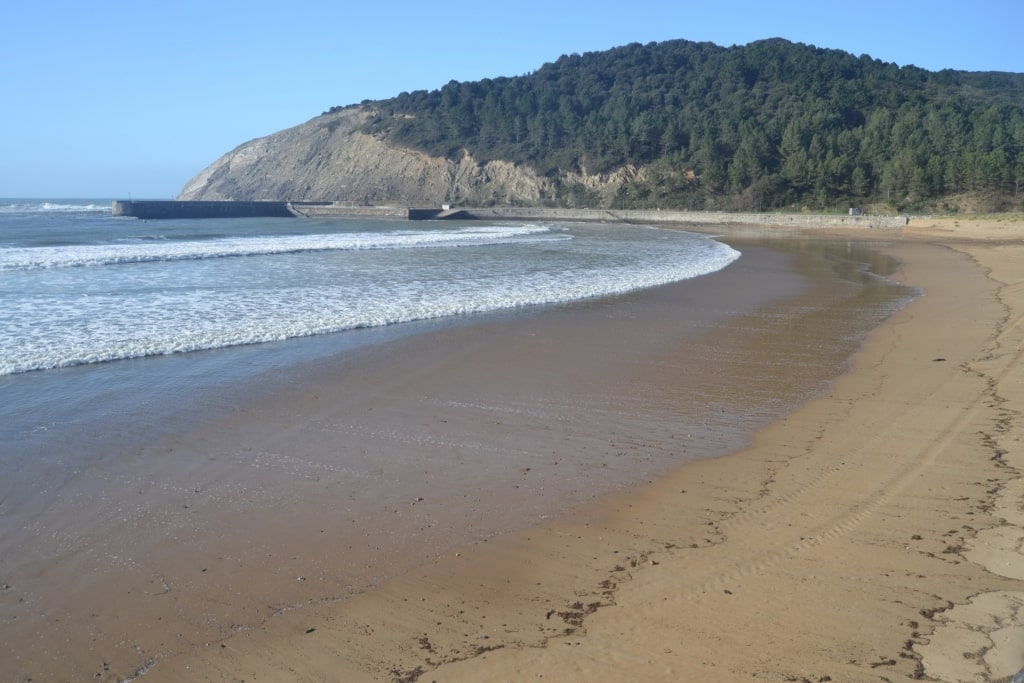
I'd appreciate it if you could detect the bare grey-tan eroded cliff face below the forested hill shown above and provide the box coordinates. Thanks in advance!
[178,108,637,206]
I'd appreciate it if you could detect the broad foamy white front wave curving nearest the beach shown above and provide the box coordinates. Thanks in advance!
[0,240,740,375]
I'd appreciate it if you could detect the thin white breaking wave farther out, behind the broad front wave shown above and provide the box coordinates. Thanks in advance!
[0,225,570,271]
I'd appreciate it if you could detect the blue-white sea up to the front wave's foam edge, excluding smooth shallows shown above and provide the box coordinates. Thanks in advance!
[0,201,738,375]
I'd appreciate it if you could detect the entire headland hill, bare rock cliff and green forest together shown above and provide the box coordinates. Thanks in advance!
[180,39,1024,211]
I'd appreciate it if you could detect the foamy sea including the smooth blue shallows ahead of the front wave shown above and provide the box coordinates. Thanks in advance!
[0,200,739,471]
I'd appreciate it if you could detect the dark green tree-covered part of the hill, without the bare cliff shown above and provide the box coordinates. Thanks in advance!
[332,39,1024,210]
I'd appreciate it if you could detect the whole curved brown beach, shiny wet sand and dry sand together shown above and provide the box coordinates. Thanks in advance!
[3,219,1024,681]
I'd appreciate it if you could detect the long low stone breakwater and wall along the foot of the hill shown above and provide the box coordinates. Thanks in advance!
[112,200,908,229]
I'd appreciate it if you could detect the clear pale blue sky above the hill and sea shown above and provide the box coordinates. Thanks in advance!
[0,0,1024,199]
